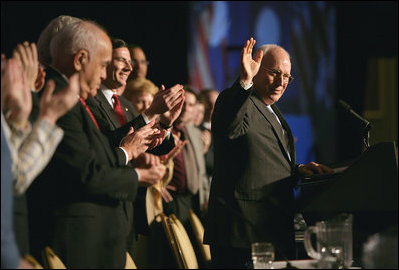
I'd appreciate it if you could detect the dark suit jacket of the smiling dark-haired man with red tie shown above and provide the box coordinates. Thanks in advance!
[87,90,175,254]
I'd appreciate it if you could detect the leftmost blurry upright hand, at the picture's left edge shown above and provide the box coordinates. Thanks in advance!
[2,58,32,126]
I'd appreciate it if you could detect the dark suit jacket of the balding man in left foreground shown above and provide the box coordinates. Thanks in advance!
[28,68,138,268]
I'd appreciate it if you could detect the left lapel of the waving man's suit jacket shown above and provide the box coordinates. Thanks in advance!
[250,94,291,167]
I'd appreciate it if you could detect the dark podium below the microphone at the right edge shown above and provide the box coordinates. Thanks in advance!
[298,142,398,214]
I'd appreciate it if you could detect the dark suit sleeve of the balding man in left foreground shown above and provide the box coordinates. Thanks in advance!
[52,104,138,200]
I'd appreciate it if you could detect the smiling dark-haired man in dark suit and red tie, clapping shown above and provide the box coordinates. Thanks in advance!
[87,38,183,254]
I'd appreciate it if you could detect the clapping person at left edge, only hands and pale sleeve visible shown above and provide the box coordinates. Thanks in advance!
[2,42,79,260]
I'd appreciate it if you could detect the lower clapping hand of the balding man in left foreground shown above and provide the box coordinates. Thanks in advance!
[133,153,166,187]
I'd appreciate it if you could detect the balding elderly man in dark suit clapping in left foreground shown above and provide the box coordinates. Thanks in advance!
[28,21,165,269]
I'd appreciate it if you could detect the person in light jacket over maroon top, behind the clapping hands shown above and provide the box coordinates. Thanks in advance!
[162,87,209,226]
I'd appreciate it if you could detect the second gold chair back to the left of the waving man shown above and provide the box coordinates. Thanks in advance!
[169,214,199,269]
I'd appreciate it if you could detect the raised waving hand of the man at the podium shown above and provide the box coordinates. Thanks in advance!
[240,37,263,84]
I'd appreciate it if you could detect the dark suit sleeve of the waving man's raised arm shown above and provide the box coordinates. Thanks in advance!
[212,81,252,139]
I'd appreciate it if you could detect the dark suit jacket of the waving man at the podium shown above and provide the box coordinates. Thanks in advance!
[204,81,295,256]
